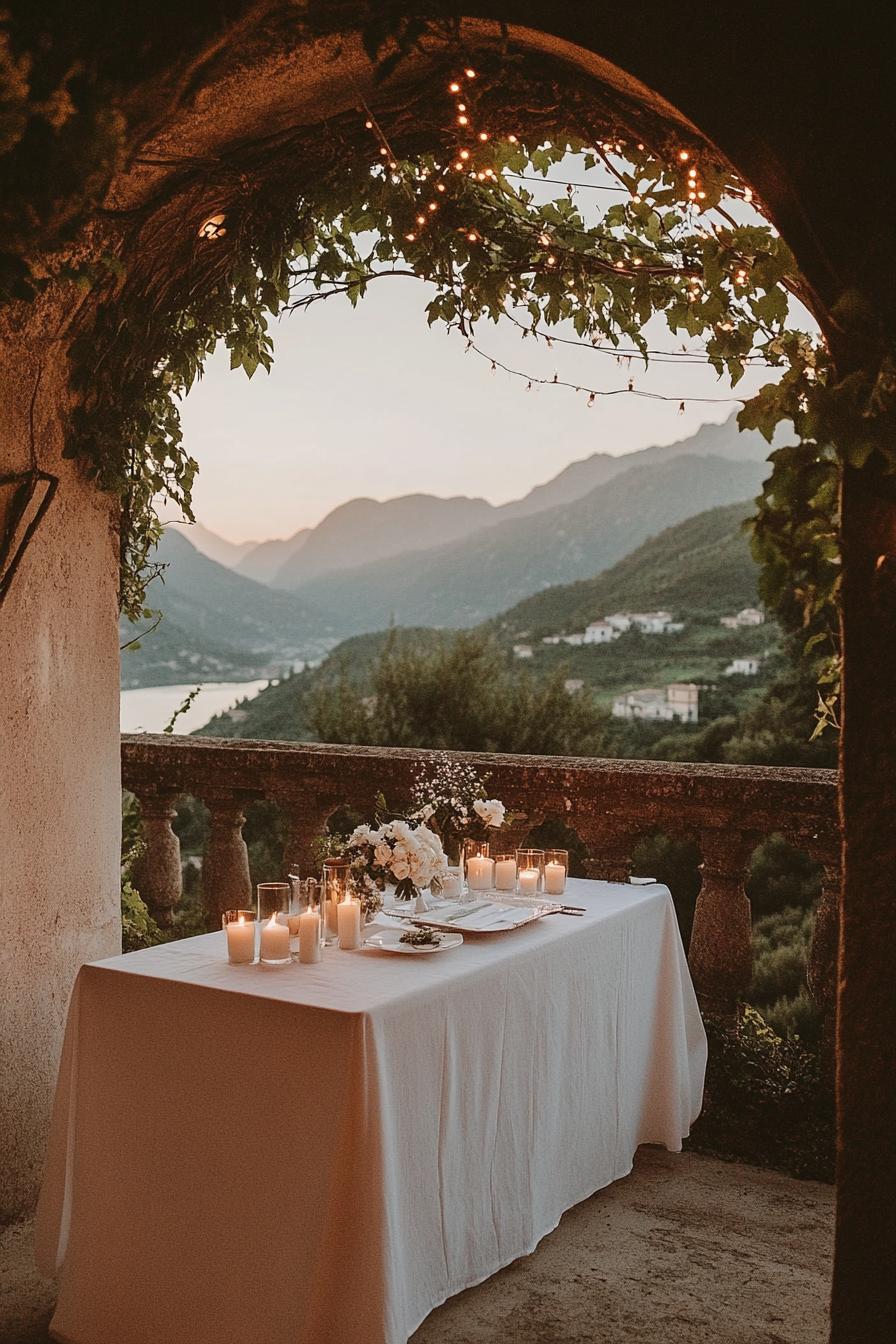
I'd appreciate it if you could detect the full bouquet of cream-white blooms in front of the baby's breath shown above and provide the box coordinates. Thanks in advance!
[345,821,447,918]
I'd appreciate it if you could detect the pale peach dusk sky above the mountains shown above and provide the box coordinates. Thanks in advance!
[183,165,795,542]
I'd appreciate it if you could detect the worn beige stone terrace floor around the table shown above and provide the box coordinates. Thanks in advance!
[0,1148,834,1344]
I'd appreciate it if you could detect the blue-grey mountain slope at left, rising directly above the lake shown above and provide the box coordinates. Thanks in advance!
[121,527,334,688]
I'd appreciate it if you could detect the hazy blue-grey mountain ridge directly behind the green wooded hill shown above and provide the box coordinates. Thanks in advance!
[291,456,766,633]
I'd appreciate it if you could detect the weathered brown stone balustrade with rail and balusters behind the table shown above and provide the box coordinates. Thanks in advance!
[122,735,840,1020]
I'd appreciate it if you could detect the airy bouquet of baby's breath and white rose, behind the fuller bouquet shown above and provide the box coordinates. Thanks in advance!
[410,751,513,864]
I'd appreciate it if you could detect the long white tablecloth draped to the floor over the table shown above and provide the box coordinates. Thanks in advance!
[38,882,705,1344]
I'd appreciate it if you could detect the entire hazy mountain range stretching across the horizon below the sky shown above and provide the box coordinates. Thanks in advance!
[122,421,768,685]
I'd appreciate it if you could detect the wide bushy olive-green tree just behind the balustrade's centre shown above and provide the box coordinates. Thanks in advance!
[308,632,606,755]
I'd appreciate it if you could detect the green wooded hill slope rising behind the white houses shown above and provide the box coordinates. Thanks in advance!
[489,503,756,638]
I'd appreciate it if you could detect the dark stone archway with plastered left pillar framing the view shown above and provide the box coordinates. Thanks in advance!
[0,0,896,1341]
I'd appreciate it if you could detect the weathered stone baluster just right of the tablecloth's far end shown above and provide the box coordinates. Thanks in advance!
[688,827,758,1020]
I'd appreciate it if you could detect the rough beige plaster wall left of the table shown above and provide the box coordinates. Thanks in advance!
[0,333,121,1231]
